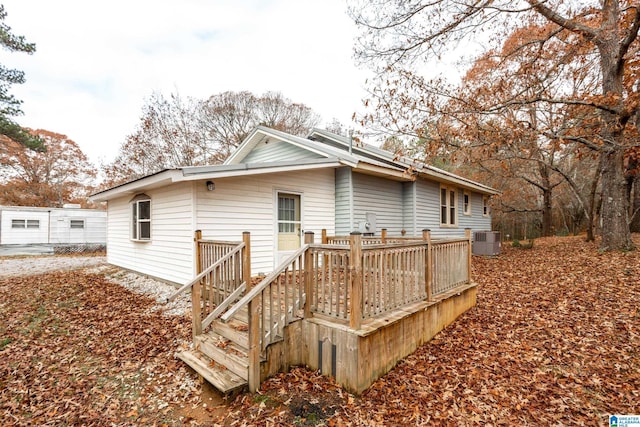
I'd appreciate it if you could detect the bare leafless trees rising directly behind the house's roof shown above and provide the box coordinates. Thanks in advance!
[102,92,319,186]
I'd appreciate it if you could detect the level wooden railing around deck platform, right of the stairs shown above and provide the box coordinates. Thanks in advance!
[307,230,471,328]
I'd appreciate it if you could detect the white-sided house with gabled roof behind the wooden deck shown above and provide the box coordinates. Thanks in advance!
[92,126,497,284]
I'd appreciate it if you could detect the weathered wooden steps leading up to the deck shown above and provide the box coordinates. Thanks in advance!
[177,312,249,394]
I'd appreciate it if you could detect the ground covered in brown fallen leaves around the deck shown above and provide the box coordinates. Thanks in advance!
[0,235,640,426]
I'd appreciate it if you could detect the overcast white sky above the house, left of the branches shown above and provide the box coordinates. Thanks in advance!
[0,0,366,165]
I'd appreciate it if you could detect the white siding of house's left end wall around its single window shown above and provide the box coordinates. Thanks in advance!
[107,183,195,284]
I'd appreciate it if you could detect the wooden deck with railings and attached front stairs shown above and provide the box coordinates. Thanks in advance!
[168,232,476,393]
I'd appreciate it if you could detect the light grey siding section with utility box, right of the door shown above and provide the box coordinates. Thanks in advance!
[352,173,403,236]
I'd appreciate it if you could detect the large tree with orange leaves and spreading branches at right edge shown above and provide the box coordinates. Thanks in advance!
[350,0,640,250]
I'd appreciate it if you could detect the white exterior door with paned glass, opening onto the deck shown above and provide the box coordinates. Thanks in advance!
[276,193,302,266]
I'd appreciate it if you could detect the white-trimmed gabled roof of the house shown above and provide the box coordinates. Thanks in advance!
[91,126,498,202]
